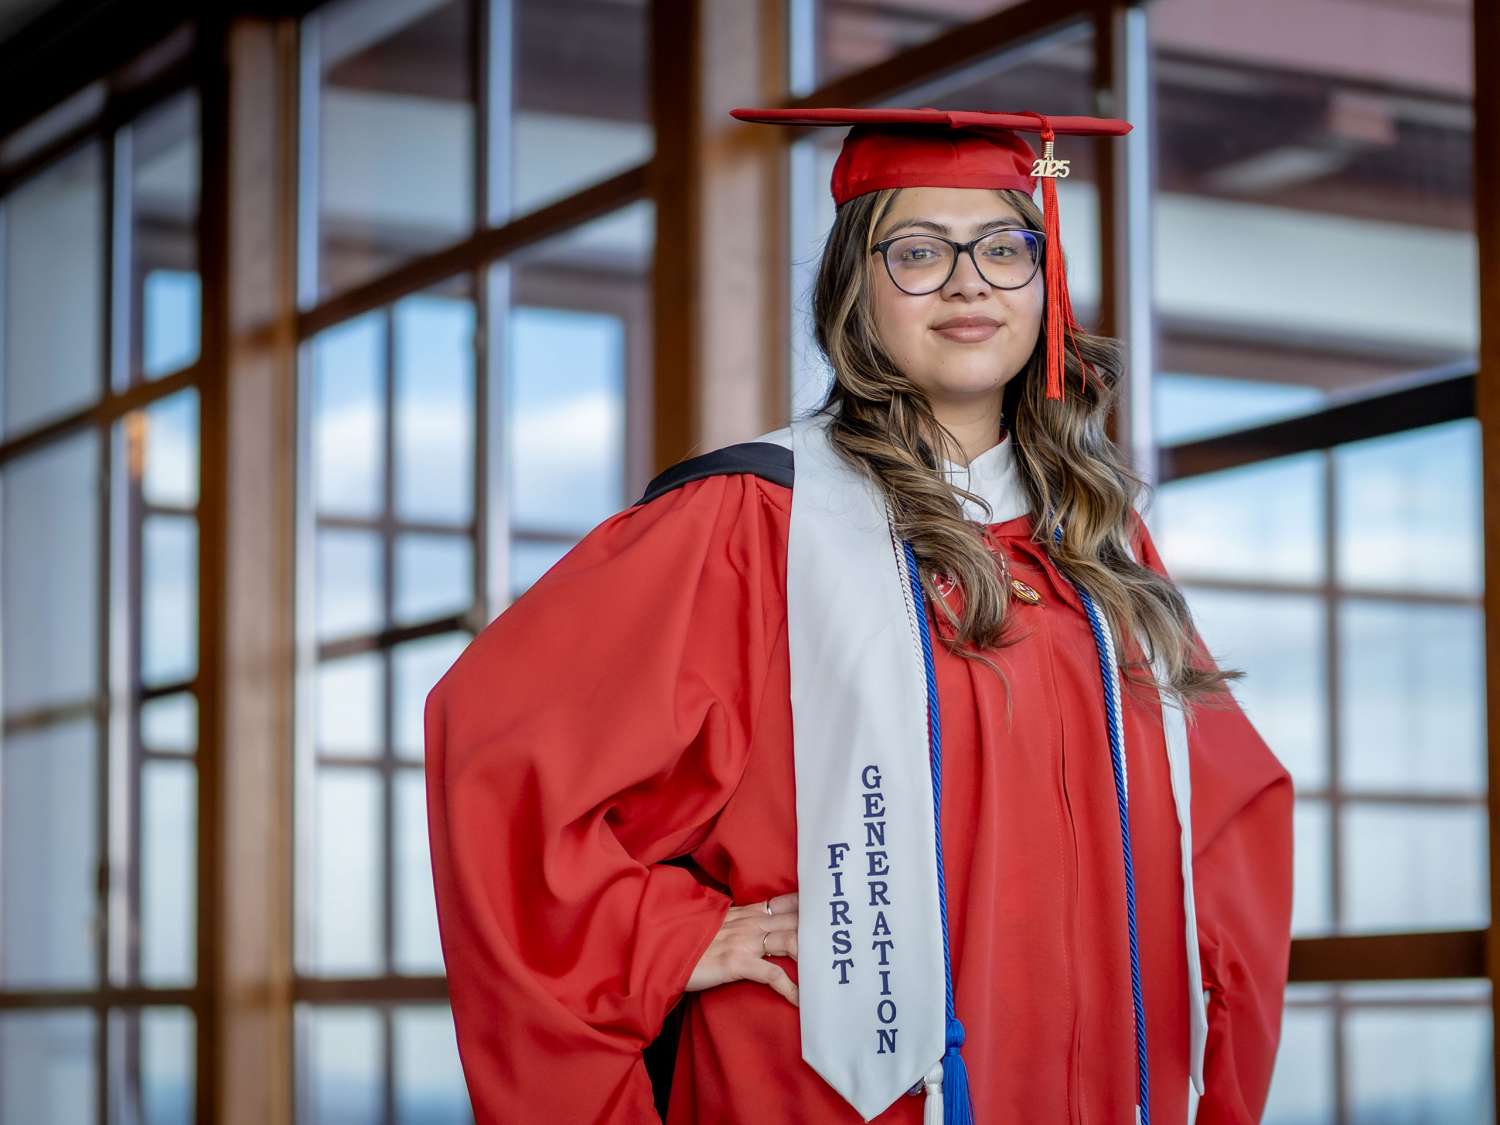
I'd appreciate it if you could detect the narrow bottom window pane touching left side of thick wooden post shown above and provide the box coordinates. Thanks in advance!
[110,1008,198,1125]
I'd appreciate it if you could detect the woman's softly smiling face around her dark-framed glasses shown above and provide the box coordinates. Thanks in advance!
[869,188,1046,411]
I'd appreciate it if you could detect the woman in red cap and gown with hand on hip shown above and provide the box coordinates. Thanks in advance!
[426,110,1292,1125]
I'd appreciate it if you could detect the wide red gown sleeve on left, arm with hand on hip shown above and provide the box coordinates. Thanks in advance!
[425,474,791,1125]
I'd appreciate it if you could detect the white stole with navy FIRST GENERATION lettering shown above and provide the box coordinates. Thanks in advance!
[755,414,1208,1125]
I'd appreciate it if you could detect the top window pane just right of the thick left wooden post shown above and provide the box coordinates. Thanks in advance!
[313,0,476,296]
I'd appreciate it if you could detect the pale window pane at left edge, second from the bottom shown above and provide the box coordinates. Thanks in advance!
[0,722,99,989]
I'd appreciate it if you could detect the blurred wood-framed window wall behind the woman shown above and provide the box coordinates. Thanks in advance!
[0,0,1500,1125]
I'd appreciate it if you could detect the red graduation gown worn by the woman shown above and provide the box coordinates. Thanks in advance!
[426,474,1292,1125]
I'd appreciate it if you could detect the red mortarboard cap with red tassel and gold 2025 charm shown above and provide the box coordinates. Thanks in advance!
[729,107,1131,399]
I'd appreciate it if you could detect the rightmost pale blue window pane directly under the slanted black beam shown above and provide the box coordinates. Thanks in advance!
[1334,419,1484,597]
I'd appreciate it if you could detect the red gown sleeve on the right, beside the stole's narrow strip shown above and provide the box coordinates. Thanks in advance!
[1137,522,1293,1125]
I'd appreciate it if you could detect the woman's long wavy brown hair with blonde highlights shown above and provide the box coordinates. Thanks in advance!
[812,188,1244,719]
